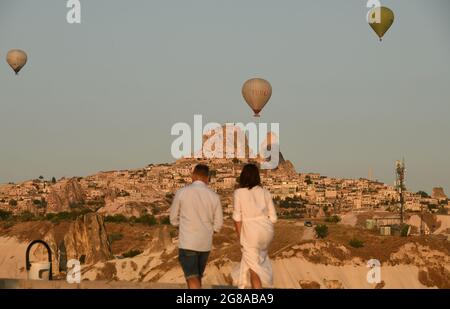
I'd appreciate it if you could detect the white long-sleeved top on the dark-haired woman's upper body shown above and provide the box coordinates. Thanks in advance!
[233,186,277,223]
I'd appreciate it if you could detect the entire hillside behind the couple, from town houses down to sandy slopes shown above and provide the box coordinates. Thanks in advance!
[0,154,450,289]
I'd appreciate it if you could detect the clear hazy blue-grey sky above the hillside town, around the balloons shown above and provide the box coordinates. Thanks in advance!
[0,0,450,193]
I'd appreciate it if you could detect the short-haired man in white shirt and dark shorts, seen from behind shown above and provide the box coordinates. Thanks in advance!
[170,164,223,289]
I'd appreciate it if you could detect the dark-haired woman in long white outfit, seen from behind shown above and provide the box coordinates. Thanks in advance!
[233,164,277,289]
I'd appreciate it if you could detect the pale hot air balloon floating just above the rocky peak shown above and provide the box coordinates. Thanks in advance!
[242,78,272,117]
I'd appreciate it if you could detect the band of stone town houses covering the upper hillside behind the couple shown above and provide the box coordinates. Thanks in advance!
[0,156,450,218]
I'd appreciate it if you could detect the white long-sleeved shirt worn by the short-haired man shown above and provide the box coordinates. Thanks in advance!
[170,181,223,252]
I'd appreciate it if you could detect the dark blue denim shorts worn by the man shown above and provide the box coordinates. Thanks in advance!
[178,248,209,279]
